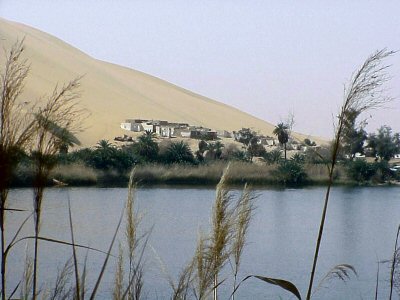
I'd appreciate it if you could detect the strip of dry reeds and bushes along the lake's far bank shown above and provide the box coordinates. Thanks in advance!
[12,161,399,187]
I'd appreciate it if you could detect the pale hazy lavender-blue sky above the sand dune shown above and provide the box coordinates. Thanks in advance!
[0,0,400,137]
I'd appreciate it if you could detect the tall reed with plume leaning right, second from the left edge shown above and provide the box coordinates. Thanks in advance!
[32,77,83,299]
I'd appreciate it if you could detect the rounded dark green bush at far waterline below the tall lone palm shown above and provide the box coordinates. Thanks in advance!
[272,160,307,185]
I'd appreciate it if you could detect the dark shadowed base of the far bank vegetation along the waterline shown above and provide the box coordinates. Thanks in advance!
[11,166,400,189]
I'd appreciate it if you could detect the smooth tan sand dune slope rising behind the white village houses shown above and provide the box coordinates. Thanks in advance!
[0,18,318,146]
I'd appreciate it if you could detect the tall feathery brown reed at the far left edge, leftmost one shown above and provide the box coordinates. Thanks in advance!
[0,40,34,299]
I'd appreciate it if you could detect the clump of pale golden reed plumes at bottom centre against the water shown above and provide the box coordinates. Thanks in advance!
[188,165,255,300]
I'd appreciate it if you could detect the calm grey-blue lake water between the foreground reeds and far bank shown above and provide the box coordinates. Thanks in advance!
[7,187,400,299]
